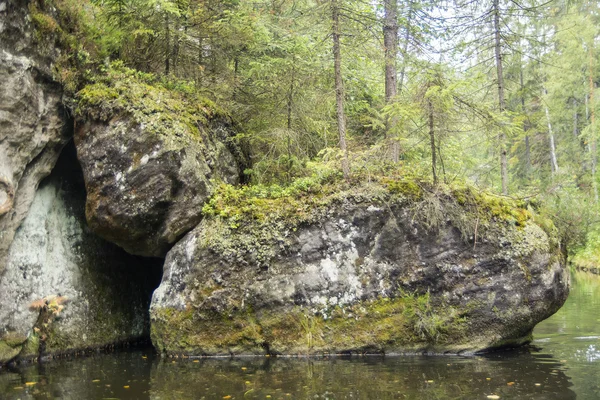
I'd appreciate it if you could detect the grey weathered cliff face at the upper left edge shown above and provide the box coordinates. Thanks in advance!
[0,0,72,277]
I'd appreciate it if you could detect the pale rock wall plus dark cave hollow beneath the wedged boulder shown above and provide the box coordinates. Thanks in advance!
[0,146,161,364]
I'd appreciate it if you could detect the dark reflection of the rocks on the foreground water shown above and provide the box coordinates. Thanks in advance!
[0,351,575,400]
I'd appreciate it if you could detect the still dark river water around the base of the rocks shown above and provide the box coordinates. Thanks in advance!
[0,273,600,400]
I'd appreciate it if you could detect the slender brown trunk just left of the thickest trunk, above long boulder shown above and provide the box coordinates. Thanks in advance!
[331,0,350,179]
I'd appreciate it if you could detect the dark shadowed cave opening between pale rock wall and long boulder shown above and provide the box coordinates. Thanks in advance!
[40,140,164,348]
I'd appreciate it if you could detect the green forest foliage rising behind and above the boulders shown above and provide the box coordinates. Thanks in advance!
[29,0,600,268]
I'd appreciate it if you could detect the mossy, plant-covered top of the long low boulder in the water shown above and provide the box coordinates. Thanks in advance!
[203,169,559,262]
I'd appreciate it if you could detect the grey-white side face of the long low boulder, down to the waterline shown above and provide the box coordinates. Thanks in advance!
[151,185,568,355]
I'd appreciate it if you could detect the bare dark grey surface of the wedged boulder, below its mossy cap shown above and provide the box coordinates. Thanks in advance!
[75,114,240,257]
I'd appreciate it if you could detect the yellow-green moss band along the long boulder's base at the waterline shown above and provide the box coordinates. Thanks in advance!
[152,293,467,355]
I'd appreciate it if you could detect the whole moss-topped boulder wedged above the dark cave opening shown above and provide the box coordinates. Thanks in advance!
[75,66,240,257]
